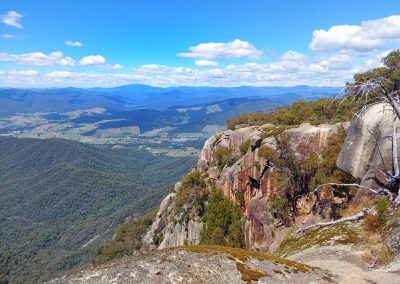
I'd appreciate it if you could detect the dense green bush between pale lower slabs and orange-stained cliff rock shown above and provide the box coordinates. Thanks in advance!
[201,189,244,247]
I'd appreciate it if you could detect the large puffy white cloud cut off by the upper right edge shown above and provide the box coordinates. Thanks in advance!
[309,15,400,52]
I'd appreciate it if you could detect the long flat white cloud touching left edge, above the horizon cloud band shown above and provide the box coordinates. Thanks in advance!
[0,51,75,66]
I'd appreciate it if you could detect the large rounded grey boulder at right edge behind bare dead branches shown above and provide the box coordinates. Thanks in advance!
[337,103,400,201]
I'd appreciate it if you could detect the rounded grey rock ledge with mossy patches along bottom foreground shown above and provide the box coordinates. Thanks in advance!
[51,246,336,284]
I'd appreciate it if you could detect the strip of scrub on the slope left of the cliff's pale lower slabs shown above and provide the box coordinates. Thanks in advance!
[92,208,158,265]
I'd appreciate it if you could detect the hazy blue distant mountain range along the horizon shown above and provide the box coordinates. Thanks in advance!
[0,85,339,116]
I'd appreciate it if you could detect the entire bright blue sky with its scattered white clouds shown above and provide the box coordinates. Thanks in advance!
[0,0,400,87]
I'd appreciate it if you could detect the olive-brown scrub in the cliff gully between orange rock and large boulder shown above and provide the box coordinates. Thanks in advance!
[258,128,356,217]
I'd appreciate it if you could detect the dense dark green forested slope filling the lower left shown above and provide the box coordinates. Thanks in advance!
[0,137,195,283]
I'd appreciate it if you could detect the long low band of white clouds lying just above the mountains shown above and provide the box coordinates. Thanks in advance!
[0,51,356,87]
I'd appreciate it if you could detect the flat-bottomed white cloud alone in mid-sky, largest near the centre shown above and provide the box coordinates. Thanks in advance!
[178,39,262,59]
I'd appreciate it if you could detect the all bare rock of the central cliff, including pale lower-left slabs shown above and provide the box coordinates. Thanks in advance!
[143,121,339,251]
